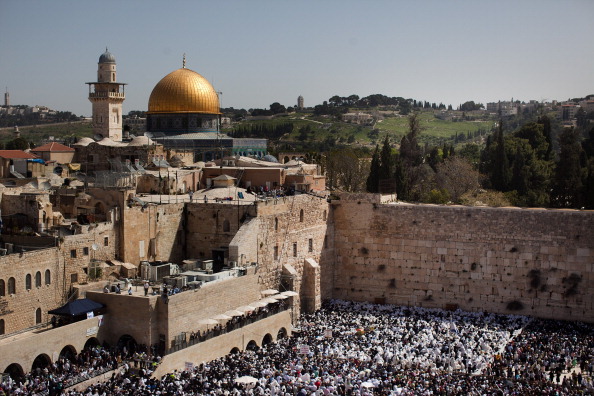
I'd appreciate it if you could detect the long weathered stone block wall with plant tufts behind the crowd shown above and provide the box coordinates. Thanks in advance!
[325,195,594,321]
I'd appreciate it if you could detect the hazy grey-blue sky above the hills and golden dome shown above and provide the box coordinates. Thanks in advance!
[0,0,594,115]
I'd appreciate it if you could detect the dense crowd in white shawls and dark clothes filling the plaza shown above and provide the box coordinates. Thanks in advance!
[0,301,594,396]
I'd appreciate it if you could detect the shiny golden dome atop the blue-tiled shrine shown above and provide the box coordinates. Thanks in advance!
[148,68,220,114]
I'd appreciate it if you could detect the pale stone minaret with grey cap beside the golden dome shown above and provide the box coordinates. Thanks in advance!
[86,48,127,142]
